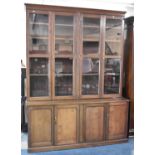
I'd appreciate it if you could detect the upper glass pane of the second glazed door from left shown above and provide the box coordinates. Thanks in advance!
[55,15,73,54]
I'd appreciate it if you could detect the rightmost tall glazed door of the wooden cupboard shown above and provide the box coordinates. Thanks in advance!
[102,16,123,97]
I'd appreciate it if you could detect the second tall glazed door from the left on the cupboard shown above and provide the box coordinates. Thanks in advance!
[54,13,76,99]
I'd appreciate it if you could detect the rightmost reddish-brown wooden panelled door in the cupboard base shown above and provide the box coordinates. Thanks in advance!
[108,103,128,139]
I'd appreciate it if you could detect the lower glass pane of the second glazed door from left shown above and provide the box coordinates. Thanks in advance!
[55,58,73,96]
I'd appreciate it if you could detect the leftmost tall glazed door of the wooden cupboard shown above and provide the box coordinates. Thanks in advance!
[26,11,51,100]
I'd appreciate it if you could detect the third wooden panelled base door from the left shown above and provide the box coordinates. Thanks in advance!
[85,106,104,142]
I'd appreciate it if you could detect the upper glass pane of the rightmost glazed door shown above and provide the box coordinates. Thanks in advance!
[105,19,122,55]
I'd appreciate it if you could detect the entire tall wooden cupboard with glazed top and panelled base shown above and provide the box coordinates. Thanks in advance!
[26,4,128,151]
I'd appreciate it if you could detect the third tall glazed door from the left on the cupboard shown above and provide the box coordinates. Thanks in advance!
[78,15,101,98]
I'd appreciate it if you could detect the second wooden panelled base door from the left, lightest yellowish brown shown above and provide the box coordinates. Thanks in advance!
[55,107,78,145]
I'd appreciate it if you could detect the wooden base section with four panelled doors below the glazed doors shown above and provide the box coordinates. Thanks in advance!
[28,100,128,152]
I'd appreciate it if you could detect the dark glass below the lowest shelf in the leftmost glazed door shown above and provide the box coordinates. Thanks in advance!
[30,76,49,97]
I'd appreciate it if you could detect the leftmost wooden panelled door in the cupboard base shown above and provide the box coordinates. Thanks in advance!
[30,108,52,146]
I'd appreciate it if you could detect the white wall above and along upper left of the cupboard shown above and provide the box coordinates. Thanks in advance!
[20,0,134,64]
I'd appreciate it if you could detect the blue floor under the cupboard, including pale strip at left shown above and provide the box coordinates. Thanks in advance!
[21,133,134,155]
